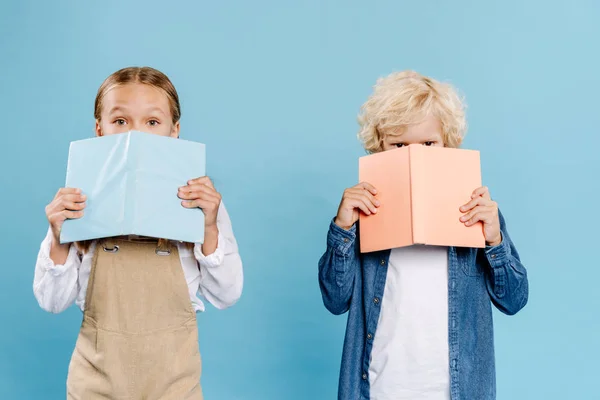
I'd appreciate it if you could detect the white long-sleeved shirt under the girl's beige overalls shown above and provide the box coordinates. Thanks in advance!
[33,203,243,313]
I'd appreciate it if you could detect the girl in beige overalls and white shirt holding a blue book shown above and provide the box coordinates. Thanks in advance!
[33,67,243,400]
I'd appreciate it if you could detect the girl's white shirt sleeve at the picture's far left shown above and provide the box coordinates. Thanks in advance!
[33,230,81,313]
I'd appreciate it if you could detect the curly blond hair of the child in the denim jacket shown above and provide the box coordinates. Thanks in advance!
[358,71,467,153]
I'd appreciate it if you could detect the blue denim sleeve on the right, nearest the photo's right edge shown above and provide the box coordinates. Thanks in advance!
[482,212,529,315]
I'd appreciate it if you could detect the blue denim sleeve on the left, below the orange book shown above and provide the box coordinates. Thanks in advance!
[319,221,360,315]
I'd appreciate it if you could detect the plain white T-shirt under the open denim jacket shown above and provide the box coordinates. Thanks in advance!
[369,245,450,400]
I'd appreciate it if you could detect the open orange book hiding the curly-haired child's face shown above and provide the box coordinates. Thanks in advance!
[359,145,485,253]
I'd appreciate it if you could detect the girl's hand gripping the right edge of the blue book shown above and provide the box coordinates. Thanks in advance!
[178,176,221,228]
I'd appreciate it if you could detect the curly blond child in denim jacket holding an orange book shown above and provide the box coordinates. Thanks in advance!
[319,72,528,400]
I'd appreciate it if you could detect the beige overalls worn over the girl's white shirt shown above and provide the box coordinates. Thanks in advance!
[67,239,202,400]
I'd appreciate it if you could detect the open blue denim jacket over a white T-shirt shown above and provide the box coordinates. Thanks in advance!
[319,214,529,400]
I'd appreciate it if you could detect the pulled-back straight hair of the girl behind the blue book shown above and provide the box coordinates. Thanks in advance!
[75,67,189,253]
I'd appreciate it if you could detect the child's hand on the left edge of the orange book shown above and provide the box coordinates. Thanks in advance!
[334,182,381,230]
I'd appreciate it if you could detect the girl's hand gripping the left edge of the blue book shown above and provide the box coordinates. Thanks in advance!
[46,188,86,244]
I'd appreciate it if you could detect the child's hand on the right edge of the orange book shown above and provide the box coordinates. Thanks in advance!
[460,186,502,246]
